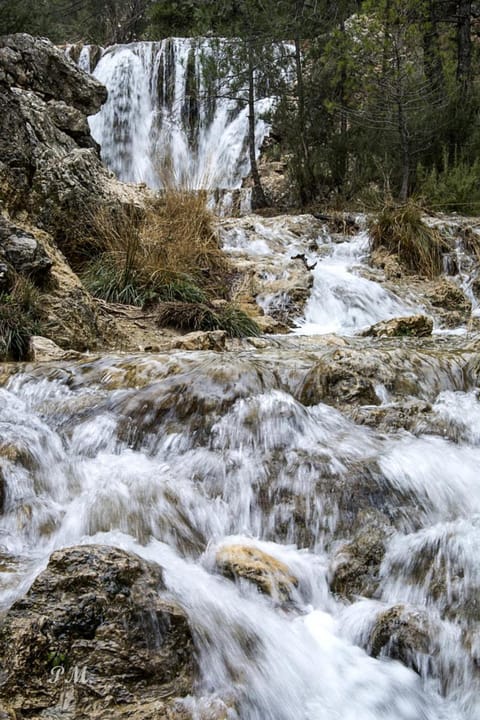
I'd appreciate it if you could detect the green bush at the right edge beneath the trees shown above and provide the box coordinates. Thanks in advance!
[418,152,480,215]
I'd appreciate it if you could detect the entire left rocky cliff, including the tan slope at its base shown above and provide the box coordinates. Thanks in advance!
[0,34,150,350]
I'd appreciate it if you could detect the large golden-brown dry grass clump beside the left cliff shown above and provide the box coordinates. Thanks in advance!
[81,191,231,306]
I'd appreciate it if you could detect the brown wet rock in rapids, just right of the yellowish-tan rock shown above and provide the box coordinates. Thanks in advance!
[330,511,393,600]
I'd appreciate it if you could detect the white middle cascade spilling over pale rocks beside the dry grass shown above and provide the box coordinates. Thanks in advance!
[222,216,422,336]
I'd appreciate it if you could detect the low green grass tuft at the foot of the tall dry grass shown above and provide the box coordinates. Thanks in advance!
[156,302,260,338]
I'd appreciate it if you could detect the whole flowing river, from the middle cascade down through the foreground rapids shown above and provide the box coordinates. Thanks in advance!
[0,219,480,720]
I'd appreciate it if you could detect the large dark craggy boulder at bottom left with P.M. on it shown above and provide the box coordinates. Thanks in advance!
[0,546,197,720]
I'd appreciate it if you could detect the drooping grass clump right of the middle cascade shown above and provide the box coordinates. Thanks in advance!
[369,201,447,278]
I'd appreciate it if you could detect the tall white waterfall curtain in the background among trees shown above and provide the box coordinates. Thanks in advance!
[86,38,273,190]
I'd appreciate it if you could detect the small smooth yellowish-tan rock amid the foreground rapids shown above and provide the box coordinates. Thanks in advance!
[216,545,298,602]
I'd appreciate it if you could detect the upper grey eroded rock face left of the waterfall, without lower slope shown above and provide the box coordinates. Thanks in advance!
[0,34,147,256]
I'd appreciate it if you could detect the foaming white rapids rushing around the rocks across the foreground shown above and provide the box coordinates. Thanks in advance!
[0,353,480,720]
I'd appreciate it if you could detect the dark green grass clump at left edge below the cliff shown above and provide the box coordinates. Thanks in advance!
[0,276,40,362]
